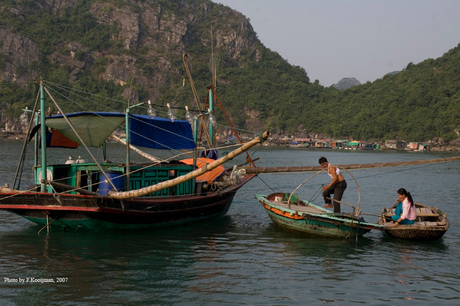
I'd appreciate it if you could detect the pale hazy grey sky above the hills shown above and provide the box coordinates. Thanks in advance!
[213,0,460,86]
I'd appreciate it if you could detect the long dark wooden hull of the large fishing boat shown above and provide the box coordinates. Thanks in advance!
[0,175,254,230]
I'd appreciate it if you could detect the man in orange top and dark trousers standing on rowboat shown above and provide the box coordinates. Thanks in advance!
[318,157,347,213]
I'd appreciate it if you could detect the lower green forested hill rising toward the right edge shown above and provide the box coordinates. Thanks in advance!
[316,45,460,141]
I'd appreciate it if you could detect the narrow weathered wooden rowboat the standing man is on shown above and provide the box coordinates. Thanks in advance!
[255,193,381,238]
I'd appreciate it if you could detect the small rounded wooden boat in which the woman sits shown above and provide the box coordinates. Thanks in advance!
[378,203,449,241]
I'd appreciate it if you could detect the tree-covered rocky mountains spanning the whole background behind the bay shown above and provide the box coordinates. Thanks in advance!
[0,0,460,141]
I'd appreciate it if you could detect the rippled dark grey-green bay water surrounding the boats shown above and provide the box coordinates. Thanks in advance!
[0,144,460,305]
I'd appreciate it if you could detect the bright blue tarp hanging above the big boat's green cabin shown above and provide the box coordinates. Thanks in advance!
[129,115,195,150]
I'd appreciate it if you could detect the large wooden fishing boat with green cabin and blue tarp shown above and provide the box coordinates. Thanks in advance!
[0,81,269,230]
